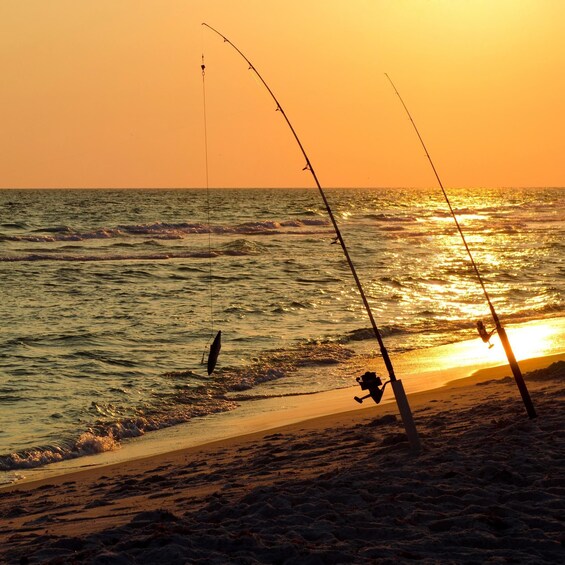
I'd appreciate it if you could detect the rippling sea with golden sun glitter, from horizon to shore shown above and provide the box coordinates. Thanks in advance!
[0,188,565,478]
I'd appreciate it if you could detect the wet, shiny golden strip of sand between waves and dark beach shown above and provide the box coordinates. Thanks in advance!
[0,317,565,484]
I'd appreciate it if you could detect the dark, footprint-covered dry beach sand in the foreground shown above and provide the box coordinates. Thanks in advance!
[0,355,565,564]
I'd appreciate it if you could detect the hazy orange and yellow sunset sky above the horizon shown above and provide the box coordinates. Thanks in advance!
[0,0,565,188]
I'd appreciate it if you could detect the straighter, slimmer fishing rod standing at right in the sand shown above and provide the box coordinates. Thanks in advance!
[385,73,537,418]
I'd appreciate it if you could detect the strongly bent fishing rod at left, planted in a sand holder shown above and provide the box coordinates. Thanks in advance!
[202,23,421,453]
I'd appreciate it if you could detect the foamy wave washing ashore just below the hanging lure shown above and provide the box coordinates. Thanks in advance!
[0,342,353,471]
